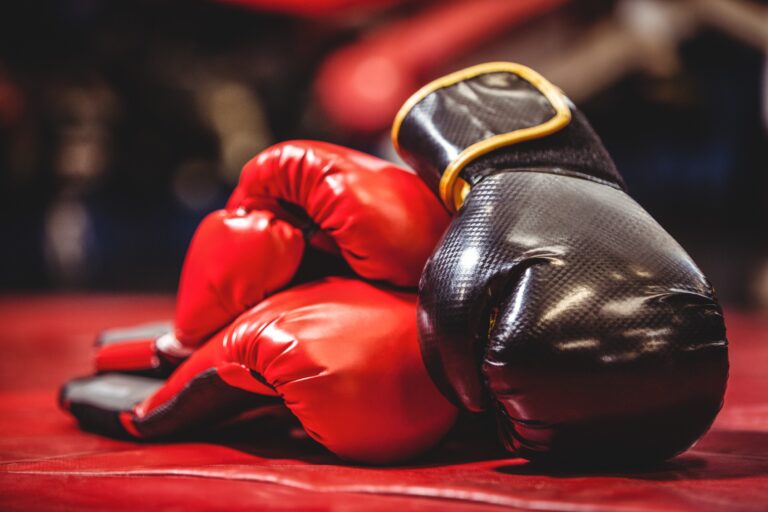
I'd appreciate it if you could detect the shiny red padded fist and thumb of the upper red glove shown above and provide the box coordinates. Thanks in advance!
[175,141,449,348]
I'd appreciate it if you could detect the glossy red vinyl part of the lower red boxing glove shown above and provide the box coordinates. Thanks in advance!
[134,278,457,464]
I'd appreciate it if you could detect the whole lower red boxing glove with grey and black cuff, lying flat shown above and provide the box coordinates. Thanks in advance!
[60,278,456,463]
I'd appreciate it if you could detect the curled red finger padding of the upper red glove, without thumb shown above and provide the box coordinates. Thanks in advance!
[232,140,450,288]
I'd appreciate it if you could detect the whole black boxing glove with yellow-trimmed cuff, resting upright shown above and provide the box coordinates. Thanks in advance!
[392,63,728,464]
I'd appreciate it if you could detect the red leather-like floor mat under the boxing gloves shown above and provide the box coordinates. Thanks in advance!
[0,296,768,511]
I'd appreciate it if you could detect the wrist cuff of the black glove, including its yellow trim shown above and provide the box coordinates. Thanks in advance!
[392,62,623,210]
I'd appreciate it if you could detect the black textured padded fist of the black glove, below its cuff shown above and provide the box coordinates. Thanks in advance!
[419,172,728,459]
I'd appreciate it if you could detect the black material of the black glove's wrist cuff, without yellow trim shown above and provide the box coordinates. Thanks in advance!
[398,73,624,190]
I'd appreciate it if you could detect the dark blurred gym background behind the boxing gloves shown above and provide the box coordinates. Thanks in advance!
[0,0,768,308]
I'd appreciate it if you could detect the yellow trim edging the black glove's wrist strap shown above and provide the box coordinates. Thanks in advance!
[392,62,571,211]
